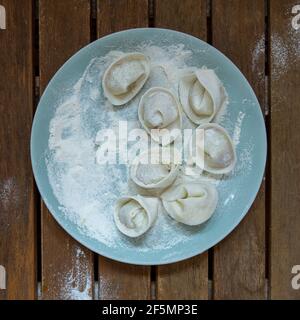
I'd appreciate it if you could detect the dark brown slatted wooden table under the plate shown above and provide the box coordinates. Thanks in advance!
[0,0,300,299]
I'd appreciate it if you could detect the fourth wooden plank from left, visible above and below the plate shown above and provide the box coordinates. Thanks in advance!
[154,0,208,299]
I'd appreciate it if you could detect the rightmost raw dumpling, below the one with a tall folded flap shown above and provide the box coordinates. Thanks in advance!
[196,123,236,174]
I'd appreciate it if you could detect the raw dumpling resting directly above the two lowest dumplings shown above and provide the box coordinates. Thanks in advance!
[130,148,179,190]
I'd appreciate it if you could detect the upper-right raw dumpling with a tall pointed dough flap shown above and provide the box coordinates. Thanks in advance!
[179,69,227,124]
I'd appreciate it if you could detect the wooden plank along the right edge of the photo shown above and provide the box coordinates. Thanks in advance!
[269,0,300,299]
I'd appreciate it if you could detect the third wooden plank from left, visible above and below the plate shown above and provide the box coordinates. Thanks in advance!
[97,0,151,299]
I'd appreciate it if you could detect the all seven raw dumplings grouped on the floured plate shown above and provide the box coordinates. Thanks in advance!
[102,52,236,237]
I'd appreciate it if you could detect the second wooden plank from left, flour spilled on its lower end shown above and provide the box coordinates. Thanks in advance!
[39,0,94,299]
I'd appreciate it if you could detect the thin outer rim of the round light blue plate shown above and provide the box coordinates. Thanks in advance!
[30,28,268,266]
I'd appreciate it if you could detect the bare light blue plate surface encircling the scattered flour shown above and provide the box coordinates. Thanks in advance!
[31,28,267,265]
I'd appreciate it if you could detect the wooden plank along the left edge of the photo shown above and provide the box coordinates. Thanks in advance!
[0,0,37,300]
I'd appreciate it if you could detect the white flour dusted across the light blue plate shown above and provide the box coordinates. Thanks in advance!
[47,45,251,252]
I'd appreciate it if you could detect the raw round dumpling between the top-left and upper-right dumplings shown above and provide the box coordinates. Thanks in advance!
[138,87,181,146]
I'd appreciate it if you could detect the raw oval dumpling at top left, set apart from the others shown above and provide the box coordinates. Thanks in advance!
[102,53,150,106]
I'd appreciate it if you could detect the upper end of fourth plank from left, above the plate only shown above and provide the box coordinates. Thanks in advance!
[154,0,206,40]
